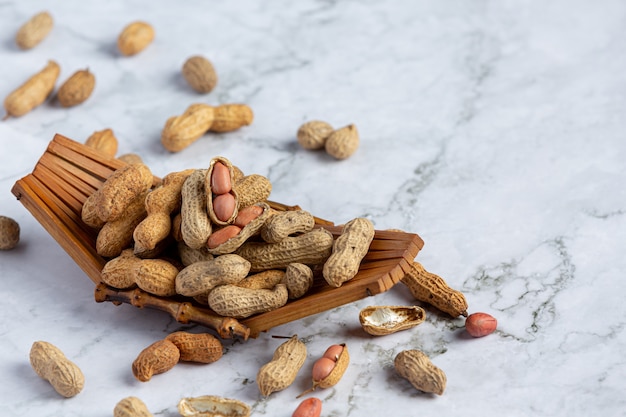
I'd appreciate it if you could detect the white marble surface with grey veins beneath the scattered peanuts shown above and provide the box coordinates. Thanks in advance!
[0,0,626,417]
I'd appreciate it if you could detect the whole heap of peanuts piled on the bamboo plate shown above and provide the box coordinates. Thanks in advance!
[81,156,374,319]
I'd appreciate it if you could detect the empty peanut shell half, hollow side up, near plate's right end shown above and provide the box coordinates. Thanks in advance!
[359,306,426,336]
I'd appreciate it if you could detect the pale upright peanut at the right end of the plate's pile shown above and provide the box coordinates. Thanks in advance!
[323,217,374,287]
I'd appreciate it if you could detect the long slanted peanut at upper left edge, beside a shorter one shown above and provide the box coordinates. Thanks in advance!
[4,60,61,119]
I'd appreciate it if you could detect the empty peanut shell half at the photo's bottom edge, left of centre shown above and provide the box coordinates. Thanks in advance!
[178,395,250,417]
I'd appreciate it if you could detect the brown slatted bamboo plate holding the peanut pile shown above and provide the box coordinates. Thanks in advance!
[11,135,424,339]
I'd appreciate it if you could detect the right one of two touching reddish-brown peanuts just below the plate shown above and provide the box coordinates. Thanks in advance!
[165,331,224,363]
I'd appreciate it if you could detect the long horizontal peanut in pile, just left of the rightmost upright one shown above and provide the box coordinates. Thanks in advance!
[235,229,333,271]
